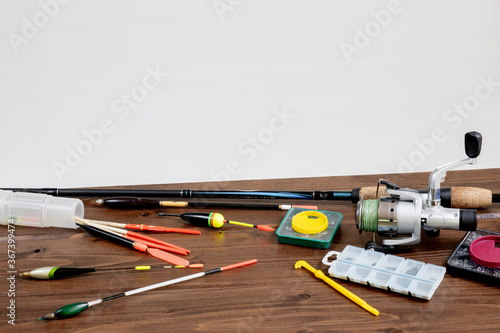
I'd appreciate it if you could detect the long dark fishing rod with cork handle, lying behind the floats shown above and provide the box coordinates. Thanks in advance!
[3,186,500,208]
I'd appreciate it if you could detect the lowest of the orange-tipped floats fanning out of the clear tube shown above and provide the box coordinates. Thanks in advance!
[77,222,189,266]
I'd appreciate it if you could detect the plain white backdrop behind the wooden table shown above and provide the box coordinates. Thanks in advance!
[0,0,500,187]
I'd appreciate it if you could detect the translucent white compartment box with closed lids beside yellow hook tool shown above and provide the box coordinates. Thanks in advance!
[322,245,446,300]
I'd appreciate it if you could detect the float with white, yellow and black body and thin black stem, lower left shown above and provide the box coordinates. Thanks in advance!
[20,264,203,280]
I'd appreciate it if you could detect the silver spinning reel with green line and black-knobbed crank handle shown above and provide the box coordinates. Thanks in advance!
[355,132,482,252]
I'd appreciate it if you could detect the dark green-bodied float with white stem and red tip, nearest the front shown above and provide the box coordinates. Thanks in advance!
[39,259,257,320]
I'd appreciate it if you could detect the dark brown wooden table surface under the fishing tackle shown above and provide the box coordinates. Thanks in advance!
[0,169,500,332]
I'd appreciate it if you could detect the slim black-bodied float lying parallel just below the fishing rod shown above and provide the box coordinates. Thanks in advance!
[95,197,318,210]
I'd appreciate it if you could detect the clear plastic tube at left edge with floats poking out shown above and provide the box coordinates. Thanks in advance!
[0,190,84,229]
